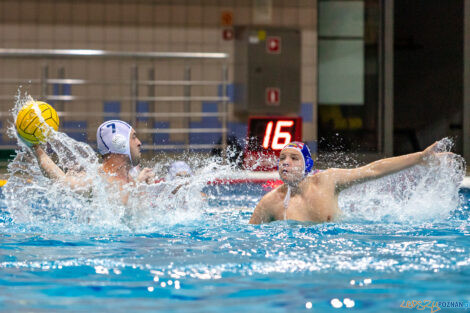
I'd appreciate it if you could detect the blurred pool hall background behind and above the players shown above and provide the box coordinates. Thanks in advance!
[0,0,470,166]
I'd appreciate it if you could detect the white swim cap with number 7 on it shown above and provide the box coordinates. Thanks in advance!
[96,120,132,163]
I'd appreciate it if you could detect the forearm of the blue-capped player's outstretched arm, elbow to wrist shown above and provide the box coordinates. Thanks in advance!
[365,152,424,177]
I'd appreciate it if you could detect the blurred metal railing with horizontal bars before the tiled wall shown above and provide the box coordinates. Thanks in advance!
[0,49,229,151]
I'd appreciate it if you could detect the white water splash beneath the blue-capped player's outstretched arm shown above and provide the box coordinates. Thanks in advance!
[338,138,465,222]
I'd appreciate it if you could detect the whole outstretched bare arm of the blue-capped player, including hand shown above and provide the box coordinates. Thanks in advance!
[323,142,437,192]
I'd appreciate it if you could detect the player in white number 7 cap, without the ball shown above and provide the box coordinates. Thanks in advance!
[32,120,155,203]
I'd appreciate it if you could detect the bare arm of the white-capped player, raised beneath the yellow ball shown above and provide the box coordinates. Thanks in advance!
[31,145,91,190]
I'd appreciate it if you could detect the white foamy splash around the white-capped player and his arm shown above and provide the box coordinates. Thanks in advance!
[2,91,224,232]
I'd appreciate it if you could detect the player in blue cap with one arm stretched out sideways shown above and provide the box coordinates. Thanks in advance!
[250,142,444,224]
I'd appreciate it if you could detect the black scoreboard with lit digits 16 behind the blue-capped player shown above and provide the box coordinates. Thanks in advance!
[244,116,302,171]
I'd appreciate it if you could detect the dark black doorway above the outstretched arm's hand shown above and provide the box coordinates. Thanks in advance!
[394,0,464,155]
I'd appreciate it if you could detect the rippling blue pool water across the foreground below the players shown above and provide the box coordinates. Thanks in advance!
[0,185,470,313]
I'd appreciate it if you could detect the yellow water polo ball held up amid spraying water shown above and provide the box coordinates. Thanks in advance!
[15,101,59,144]
